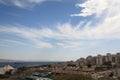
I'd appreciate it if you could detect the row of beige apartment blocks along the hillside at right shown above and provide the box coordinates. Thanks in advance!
[77,53,120,66]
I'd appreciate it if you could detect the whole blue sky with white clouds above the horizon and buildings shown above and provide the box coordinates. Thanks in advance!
[0,0,120,61]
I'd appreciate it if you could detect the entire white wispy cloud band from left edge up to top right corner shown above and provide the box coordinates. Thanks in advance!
[0,0,120,48]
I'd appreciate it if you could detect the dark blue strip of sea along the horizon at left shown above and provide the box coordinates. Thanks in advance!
[0,62,57,68]
